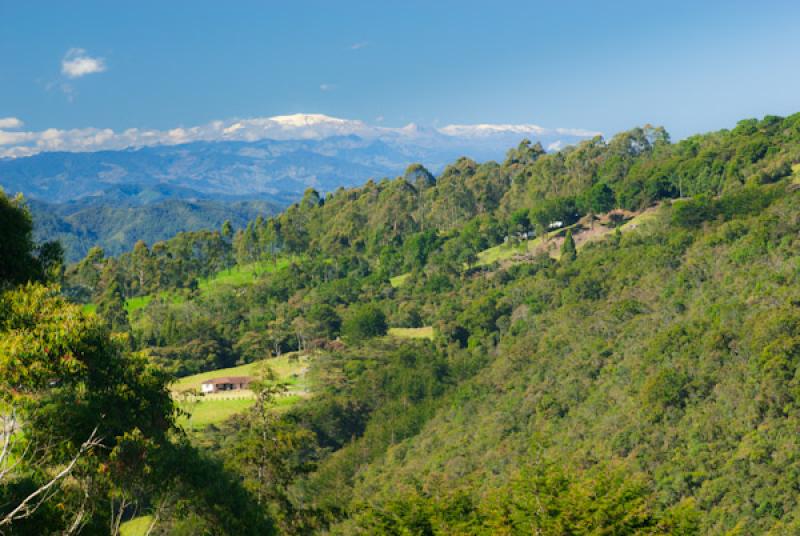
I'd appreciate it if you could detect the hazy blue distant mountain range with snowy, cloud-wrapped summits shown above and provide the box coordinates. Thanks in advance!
[0,114,597,260]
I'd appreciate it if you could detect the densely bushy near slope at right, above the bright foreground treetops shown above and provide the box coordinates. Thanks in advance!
[339,184,800,534]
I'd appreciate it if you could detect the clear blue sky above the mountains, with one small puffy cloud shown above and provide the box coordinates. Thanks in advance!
[0,0,800,143]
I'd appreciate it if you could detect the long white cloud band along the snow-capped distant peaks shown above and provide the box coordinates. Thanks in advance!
[0,114,598,158]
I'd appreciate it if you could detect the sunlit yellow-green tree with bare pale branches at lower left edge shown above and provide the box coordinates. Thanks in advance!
[0,285,173,532]
